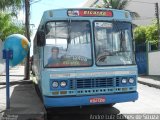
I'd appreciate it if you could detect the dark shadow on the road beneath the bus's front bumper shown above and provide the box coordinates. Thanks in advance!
[47,105,127,120]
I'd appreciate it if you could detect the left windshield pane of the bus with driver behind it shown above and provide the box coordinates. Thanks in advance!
[44,21,92,67]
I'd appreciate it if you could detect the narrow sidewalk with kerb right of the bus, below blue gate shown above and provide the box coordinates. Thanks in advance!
[138,76,160,89]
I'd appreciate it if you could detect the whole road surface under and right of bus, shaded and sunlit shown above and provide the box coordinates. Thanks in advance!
[48,84,160,120]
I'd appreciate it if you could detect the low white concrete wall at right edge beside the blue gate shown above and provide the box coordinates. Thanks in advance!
[148,51,160,75]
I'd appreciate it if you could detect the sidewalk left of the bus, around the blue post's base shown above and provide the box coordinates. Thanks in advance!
[0,66,46,120]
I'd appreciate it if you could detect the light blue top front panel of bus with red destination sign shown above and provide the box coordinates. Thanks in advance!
[40,8,132,26]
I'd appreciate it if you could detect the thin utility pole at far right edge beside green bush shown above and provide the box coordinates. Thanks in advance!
[155,3,160,50]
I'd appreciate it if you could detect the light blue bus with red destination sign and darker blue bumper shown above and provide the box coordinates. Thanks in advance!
[33,8,138,108]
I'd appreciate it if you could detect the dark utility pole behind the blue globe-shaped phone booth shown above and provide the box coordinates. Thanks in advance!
[24,0,30,80]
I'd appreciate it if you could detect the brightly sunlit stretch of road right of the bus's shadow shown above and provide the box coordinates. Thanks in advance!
[115,84,160,114]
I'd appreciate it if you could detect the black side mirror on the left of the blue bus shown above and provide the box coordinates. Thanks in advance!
[37,31,46,47]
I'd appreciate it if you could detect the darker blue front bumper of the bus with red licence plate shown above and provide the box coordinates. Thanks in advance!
[43,92,138,108]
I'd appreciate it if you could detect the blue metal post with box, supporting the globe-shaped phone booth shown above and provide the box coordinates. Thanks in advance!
[3,50,13,109]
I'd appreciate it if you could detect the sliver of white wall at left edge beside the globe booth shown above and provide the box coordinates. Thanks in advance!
[0,40,5,75]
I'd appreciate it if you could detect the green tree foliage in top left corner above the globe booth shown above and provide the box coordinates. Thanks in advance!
[0,0,25,40]
